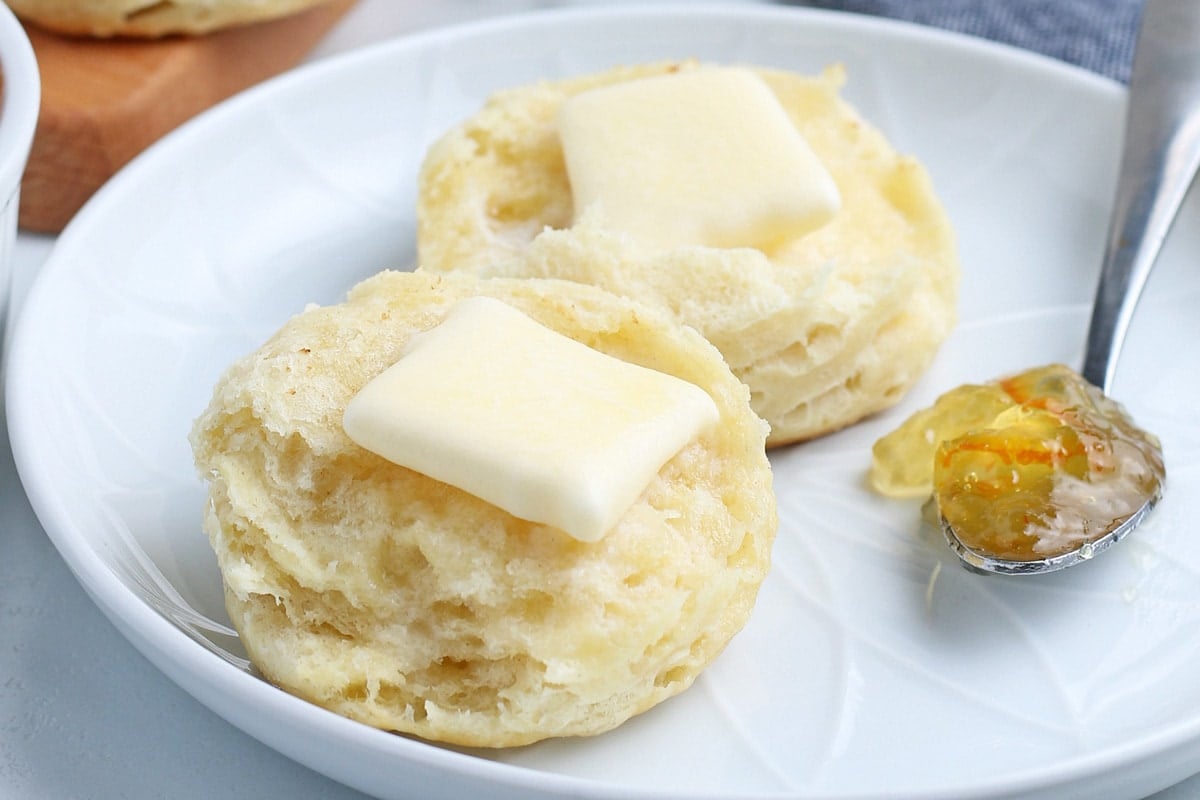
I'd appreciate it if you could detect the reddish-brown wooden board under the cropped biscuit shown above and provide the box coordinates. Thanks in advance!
[20,0,354,233]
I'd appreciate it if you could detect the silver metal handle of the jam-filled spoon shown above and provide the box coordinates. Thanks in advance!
[1082,0,1200,392]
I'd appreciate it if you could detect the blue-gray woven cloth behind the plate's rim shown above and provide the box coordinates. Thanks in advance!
[804,0,1142,82]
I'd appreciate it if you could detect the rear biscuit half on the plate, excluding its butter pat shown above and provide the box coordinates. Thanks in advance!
[418,62,959,446]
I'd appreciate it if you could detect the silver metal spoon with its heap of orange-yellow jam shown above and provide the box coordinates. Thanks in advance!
[871,0,1200,573]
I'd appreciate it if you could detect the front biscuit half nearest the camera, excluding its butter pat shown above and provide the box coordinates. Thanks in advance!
[191,272,776,747]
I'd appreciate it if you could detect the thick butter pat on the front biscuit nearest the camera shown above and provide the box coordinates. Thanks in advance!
[342,297,718,542]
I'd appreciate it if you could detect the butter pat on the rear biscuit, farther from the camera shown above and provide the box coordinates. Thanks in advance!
[558,67,841,251]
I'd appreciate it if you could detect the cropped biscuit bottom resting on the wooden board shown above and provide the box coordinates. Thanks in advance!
[8,0,336,38]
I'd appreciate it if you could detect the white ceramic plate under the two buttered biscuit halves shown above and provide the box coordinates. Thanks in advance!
[7,7,1200,798]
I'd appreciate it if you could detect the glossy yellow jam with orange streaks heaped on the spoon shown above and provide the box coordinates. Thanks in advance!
[871,365,1165,561]
